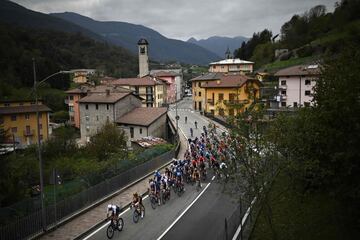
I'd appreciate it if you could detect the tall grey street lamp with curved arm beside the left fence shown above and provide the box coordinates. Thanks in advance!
[32,58,70,231]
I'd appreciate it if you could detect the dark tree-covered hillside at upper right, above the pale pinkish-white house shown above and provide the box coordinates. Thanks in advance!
[234,0,360,69]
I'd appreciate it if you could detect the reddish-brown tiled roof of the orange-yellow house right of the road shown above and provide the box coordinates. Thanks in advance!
[202,74,259,88]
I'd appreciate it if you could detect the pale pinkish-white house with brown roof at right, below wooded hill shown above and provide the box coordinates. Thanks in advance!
[275,65,320,107]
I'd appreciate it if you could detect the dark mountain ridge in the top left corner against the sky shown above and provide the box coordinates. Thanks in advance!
[0,0,105,41]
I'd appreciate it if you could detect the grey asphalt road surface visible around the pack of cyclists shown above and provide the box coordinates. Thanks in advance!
[81,99,236,240]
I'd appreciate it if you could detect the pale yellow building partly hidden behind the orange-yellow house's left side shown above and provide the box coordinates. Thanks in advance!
[190,73,223,112]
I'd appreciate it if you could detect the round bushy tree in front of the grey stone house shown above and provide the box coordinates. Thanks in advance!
[87,122,127,161]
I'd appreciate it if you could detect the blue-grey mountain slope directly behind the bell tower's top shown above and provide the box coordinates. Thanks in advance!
[51,12,219,65]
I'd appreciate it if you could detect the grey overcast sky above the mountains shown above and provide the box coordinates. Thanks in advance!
[13,0,337,40]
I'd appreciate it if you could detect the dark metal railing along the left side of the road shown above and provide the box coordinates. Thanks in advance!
[0,148,180,240]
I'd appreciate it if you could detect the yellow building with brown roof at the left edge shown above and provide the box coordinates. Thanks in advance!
[0,101,51,147]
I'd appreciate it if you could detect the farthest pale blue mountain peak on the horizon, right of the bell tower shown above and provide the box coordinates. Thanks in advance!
[187,36,248,58]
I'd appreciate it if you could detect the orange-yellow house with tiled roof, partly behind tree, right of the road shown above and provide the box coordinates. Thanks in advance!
[202,74,261,117]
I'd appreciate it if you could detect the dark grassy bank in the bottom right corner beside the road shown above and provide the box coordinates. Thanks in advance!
[250,176,360,240]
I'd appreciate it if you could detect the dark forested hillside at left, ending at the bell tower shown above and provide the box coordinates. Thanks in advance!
[0,24,137,108]
